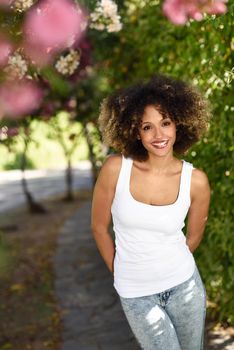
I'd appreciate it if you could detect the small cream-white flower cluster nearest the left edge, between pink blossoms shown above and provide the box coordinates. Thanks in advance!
[4,52,28,79]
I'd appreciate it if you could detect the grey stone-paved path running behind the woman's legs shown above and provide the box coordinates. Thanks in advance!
[54,201,234,350]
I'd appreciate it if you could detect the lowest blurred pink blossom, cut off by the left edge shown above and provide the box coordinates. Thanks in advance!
[0,79,43,118]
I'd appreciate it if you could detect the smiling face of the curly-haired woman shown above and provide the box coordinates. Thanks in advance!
[139,105,176,155]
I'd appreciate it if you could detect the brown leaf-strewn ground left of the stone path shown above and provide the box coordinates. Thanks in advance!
[0,191,90,350]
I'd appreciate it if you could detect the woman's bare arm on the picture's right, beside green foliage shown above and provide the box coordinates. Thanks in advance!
[186,169,210,253]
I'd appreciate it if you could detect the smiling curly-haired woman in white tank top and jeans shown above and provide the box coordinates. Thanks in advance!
[91,75,210,350]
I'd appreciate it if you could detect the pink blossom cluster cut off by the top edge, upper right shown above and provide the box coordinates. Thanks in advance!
[163,0,227,25]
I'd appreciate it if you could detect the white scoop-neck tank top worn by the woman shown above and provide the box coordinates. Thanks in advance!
[111,155,195,298]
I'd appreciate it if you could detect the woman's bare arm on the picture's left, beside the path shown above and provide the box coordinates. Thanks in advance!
[91,155,121,274]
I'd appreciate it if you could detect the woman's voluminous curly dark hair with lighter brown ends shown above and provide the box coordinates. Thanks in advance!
[98,74,210,161]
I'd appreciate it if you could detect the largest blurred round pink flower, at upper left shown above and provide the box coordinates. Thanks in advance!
[23,0,85,64]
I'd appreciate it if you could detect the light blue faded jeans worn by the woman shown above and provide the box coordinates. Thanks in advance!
[119,266,206,350]
